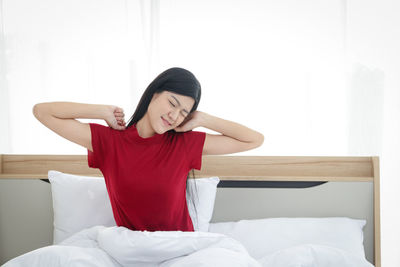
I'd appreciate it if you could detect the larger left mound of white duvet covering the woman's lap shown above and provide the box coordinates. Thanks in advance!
[3,226,261,267]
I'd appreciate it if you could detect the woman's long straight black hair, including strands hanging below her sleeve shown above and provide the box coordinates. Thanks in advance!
[126,67,201,230]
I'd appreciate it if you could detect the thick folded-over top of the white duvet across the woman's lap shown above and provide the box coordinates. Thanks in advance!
[97,227,260,267]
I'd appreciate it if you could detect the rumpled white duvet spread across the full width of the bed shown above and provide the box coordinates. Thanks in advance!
[3,226,373,267]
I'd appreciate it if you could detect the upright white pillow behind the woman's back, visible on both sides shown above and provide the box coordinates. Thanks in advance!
[48,170,219,244]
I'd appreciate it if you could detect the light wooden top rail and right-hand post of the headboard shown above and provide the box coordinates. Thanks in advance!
[0,154,381,267]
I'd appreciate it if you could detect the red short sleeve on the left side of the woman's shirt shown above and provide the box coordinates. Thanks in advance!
[87,123,112,169]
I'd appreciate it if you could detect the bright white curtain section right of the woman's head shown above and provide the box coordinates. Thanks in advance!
[160,0,348,155]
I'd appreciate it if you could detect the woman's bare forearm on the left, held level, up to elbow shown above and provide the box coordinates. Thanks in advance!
[33,102,110,119]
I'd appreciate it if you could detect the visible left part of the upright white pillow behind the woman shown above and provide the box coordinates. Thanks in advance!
[48,170,116,244]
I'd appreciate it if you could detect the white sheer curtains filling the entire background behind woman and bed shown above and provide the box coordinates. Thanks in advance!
[0,0,400,266]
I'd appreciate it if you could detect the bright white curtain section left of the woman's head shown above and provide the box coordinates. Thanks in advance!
[0,0,158,154]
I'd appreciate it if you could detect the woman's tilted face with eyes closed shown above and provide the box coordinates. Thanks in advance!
[147,91,194,134]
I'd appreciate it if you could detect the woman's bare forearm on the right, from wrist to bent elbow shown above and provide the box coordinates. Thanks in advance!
[201,112,264,143]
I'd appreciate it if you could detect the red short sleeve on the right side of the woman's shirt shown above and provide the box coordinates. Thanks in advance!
[185,131,206,170]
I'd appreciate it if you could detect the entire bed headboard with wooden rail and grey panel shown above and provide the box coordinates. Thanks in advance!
[0,154,381,267]
